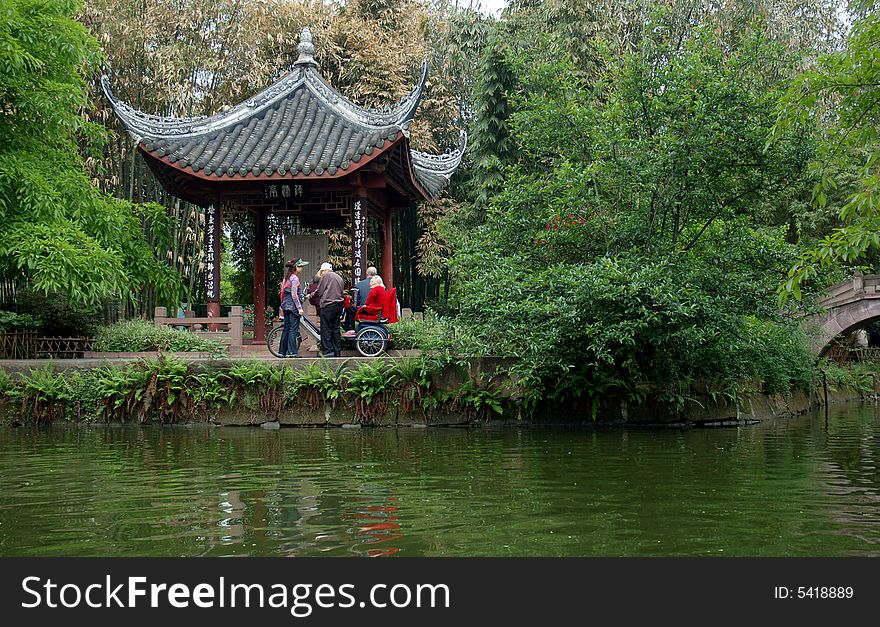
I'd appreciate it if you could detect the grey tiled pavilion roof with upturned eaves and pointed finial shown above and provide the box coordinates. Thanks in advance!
[102,28,466,197]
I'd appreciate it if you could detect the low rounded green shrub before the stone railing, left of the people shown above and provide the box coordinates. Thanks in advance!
[95,320,225,354]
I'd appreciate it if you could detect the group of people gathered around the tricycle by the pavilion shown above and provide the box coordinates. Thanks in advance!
[279,259,387,357]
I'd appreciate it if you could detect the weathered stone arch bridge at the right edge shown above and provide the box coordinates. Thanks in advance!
[805,274,880,355]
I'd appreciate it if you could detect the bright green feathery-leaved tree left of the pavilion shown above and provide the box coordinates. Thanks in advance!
[0,0,179,305]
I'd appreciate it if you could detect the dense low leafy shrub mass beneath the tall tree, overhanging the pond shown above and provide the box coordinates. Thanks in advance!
[446,251,814,406]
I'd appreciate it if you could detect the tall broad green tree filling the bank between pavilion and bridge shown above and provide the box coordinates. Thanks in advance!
[451,14,812,408]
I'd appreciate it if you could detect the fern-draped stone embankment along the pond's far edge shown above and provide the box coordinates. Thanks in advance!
[0,356,880,428]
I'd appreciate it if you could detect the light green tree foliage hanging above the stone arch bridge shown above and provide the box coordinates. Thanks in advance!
[769,0,880,299]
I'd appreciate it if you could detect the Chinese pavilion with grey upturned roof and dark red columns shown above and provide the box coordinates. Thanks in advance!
[101,28,467,343]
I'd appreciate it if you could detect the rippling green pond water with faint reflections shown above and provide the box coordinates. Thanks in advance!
[0,405,880,556]
